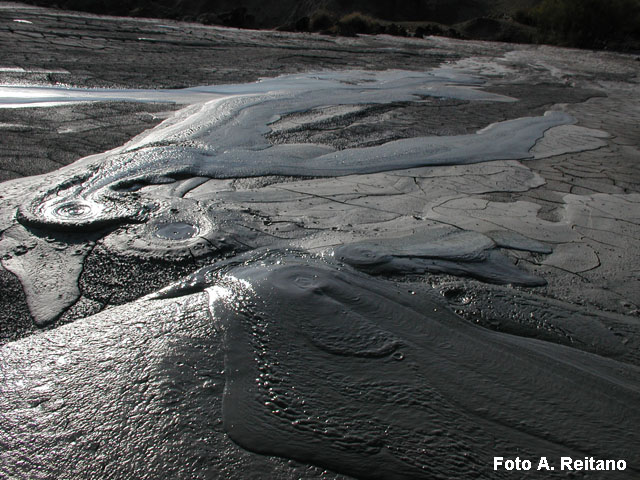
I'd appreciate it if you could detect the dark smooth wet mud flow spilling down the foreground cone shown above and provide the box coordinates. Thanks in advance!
[161,253,640,479]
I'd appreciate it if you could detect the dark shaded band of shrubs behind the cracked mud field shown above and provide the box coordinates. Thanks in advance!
[18,0,640,50]
